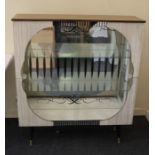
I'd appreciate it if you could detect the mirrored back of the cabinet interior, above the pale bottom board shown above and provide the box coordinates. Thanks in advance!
[22,21,133,98]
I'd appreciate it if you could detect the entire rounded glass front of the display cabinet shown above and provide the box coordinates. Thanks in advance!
[22,21,133,121]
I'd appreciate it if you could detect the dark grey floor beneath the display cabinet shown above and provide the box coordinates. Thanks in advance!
[6,117,149,155]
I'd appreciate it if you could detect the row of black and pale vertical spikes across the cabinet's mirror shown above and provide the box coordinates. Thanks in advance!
[28,52,121,95]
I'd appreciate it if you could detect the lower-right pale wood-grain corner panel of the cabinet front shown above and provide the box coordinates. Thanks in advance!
[100,78,138,125]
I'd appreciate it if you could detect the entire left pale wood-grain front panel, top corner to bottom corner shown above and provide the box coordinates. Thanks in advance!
[14,22,52,126]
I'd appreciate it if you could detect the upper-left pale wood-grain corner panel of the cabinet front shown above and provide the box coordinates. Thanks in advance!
[13,21,52,78]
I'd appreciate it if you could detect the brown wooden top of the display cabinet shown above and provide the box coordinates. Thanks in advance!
[12,14,145,23]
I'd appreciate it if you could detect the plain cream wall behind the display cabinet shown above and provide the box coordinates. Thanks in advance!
[5,0,149,115]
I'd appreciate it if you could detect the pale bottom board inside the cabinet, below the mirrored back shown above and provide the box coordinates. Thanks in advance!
[28,98,123,121]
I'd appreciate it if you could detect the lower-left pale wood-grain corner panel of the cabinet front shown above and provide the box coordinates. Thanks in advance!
[16,79,53,126]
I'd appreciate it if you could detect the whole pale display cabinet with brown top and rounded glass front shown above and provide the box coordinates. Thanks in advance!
[12,14,145,143]
